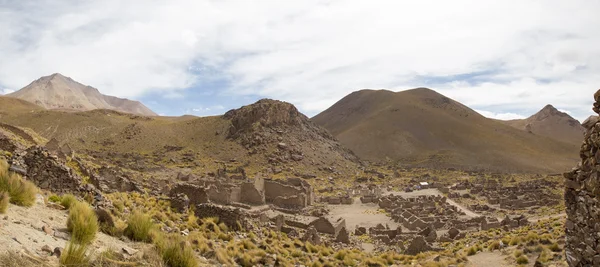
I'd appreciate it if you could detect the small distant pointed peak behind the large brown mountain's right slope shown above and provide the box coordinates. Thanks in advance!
[501,105,584,147]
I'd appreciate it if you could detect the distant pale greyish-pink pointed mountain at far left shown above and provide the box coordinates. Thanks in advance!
[7,73,156,116]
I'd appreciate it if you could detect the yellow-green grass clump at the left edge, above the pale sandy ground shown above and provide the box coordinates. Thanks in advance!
[0,167,38,207]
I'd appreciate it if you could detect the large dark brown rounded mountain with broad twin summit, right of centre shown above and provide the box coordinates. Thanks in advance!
[312,88,578,172]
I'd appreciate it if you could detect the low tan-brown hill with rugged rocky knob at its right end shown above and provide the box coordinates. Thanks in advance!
[0,100,359,184]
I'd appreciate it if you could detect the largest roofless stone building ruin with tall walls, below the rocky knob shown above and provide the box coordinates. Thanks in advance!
[169,177,314,213]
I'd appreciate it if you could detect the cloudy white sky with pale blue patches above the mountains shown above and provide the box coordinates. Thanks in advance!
[0,0,600,120]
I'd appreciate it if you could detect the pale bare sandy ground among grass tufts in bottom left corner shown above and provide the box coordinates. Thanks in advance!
[0,196,135,263]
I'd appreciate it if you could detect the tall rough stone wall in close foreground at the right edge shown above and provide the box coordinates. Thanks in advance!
[564,90,600,266]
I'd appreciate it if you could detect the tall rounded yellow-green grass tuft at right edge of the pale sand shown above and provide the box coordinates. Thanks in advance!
[67,201,98,245]
